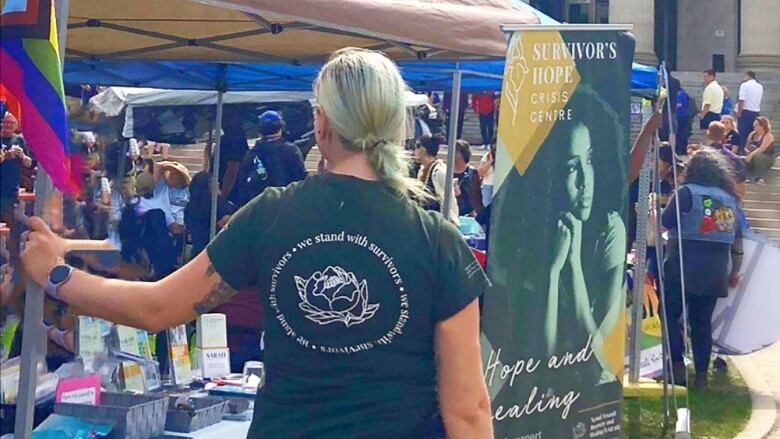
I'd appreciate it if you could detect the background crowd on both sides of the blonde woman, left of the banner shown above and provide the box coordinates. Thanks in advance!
[0,81,497,368]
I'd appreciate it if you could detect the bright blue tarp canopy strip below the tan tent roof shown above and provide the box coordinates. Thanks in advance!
[65,60,657,91]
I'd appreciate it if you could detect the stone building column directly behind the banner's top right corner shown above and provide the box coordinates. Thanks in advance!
[609,0,656,65]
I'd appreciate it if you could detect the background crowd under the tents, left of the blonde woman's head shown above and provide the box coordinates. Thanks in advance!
[0,104,306,367]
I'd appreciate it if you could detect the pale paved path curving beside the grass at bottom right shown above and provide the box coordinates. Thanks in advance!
[732,342,780,439]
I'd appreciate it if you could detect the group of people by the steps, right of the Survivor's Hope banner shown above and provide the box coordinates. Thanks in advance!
[629,70,778,387]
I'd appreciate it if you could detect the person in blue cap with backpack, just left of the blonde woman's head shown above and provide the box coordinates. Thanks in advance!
[231,111,306,206]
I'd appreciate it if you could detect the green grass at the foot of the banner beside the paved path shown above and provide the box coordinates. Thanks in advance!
[623,362,751,439]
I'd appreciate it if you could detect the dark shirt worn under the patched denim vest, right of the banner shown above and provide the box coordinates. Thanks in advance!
[661,186,742,297]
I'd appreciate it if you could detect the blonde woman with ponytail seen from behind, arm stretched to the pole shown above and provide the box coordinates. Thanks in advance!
[24,49,492,438]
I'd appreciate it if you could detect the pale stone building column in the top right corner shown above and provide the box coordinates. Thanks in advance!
[737,0,780,71]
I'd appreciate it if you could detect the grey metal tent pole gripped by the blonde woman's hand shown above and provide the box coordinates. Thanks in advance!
[14,0,69,439]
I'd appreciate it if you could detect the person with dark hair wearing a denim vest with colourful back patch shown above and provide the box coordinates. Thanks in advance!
[662,148,742,387]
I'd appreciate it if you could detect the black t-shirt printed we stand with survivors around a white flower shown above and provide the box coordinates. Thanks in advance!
[207,174,488,438]
